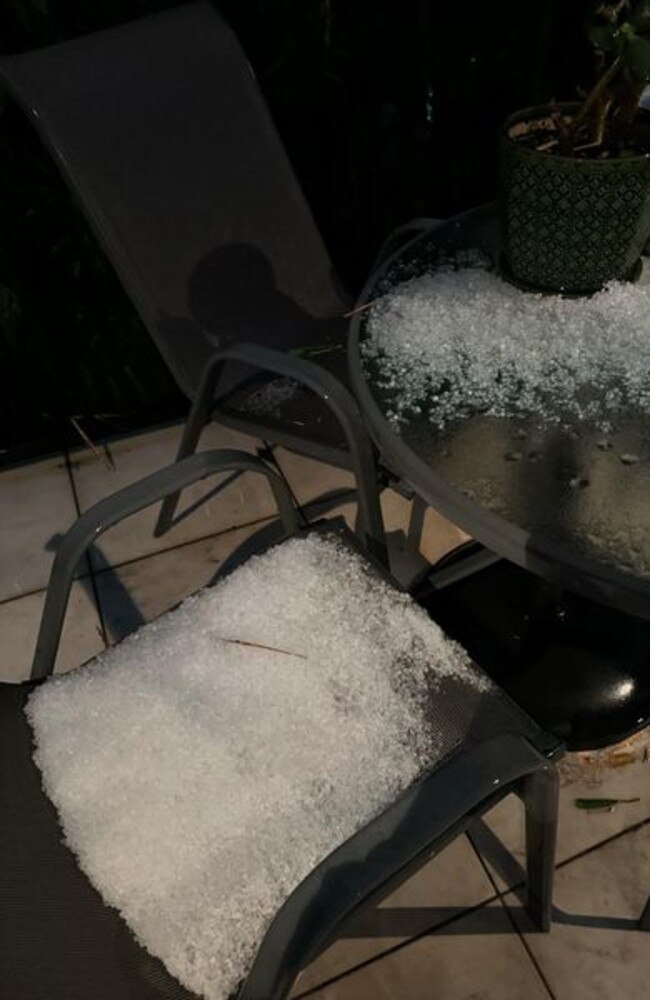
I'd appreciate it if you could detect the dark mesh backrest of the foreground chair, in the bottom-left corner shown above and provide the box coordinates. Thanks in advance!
[0,684,195,1000]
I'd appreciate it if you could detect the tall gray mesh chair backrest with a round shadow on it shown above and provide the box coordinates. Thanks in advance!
[0,0,344,395]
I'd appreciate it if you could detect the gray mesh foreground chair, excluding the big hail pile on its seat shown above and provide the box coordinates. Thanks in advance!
[0,408,561,1000]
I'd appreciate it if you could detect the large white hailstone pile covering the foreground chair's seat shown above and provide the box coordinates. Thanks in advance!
[27,535,490,1000]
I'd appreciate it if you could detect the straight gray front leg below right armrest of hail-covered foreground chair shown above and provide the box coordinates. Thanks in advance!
[523,764,559,932]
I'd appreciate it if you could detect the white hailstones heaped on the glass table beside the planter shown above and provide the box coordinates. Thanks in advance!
[363,268,650,430]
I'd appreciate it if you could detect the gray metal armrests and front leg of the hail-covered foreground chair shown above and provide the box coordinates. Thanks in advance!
[27,451,562,1000]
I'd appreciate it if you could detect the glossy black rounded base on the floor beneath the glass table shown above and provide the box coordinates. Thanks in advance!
[414,543,650,750]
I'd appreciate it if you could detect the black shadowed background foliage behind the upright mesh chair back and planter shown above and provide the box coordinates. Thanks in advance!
[0,0,591,460]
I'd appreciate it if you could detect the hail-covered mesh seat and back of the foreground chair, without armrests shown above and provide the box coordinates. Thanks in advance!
[5,529,540,1000]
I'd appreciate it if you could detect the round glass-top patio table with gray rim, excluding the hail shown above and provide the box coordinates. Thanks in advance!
[349,206,650,619]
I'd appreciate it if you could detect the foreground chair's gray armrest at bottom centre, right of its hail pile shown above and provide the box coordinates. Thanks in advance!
[238,732,553,1000]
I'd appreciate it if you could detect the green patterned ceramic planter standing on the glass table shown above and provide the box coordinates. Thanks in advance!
[499,104,650,294]
